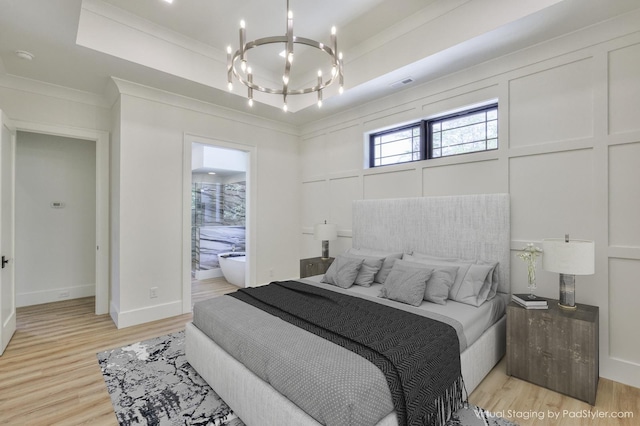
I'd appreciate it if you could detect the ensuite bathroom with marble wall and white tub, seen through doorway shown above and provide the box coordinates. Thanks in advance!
[191,143,248,287]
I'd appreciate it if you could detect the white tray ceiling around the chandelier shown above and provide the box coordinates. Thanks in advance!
[0,0,640,124]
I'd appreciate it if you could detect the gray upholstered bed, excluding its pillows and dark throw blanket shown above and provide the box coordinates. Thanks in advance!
[186,194,510,426]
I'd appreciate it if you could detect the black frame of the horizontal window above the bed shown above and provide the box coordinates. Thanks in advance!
[369,102,499,168]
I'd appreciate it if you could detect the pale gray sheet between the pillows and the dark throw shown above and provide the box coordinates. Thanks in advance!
[300,275,509,350]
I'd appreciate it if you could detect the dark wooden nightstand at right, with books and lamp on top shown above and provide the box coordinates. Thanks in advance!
[507,299,599,405]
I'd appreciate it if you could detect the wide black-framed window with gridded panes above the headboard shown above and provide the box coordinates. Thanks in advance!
[369,104,498,167]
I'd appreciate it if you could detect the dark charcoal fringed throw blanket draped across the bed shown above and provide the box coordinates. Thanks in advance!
[229,281,463,426]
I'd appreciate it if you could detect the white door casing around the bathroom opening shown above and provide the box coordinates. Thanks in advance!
[182,133,258,314]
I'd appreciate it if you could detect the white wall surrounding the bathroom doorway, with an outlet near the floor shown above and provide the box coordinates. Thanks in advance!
[111,81,299,327]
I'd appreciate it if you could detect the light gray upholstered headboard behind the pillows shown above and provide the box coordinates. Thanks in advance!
[353,194,511,293]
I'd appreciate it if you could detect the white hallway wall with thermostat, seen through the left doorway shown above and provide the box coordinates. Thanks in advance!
[15,132,96,306]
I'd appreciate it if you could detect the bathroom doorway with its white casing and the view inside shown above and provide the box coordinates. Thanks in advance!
[183,135,256,312]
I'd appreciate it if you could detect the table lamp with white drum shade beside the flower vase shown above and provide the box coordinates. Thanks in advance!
[542,234,595,310]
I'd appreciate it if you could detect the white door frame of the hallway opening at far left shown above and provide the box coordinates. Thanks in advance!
[12,120,110,315]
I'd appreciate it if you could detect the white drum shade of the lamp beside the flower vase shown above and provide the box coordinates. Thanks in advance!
[542,238,595,275]
